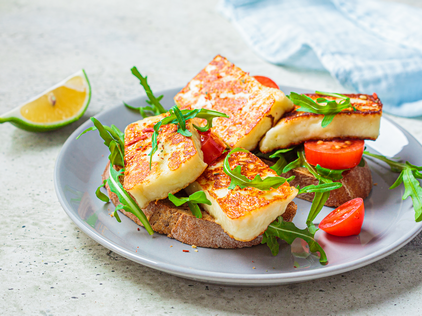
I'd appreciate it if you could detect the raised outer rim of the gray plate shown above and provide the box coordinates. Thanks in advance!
[54,85,422,286]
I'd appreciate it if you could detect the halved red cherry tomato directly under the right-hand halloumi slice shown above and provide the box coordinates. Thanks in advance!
[305,140,365,170]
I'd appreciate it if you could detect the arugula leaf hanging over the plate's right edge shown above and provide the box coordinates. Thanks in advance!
[363,151,422,222]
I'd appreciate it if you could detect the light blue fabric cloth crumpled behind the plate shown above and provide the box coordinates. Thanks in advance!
[219,0,422,117]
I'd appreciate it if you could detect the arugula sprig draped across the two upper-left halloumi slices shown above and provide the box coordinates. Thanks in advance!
[148,105,229,169]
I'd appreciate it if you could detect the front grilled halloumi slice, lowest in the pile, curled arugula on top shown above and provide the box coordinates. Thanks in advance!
[185,152,298,241]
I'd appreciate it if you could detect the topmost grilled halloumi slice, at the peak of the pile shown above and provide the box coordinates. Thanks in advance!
[174,55,293,150]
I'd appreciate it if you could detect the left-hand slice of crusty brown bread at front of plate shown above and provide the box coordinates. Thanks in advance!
[102,164,297,248]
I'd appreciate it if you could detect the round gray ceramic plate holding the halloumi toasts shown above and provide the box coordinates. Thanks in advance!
[55,87,422,285]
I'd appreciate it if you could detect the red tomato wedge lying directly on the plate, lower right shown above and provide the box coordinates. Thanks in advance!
[319,198,365,237]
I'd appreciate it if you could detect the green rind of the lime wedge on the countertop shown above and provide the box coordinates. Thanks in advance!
[0,69,91,132]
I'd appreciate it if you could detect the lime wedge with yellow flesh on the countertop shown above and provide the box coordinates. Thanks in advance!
[0,69,91,132]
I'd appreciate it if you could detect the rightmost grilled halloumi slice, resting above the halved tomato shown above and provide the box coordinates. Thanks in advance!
[259,94,382,153]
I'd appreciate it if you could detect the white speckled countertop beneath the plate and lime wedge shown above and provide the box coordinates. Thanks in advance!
[0,0,422,315]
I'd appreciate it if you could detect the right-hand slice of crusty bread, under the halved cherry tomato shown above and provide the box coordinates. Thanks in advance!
[276,160,373,207]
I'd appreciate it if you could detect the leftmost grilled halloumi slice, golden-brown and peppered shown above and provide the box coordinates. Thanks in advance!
[123,115,207,208]
